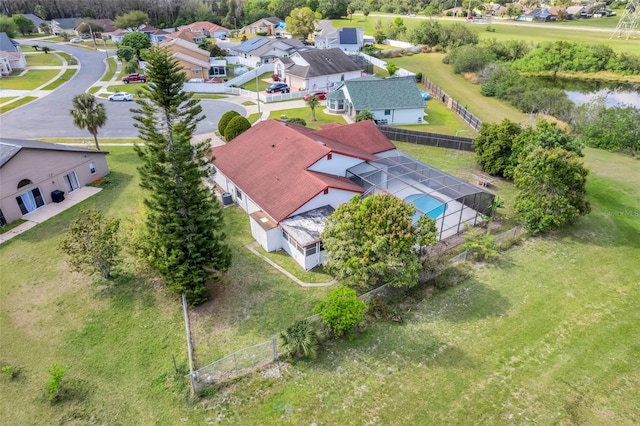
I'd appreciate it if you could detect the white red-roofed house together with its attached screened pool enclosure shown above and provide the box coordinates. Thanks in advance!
[212,120,494,270]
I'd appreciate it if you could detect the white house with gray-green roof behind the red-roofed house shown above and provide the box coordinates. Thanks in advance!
[327,77,425,125]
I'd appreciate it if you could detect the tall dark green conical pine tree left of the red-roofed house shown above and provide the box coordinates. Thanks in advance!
[132,49,231,305]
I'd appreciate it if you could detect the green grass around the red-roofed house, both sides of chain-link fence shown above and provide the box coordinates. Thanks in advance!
[0,140,640,425]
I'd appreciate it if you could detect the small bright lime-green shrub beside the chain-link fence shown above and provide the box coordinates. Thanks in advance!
[314,285,367,339]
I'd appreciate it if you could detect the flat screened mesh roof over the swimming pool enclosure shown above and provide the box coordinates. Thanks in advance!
[347,151,495,214]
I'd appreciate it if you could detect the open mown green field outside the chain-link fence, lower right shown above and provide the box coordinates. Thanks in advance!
[191,150,640,425]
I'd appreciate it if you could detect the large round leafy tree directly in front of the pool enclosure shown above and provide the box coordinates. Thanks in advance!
[322,194,437,289]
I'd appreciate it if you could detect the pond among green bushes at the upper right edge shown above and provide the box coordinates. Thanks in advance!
[534,77,640,108]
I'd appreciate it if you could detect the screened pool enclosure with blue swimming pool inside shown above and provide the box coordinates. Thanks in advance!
[347,151,495,240]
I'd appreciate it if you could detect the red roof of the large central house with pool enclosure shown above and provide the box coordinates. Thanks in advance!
[213,120,395,222]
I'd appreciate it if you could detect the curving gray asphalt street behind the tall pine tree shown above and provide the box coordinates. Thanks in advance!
[0,41,245,139]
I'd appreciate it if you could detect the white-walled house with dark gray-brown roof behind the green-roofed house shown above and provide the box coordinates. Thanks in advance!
[273,48,362,90]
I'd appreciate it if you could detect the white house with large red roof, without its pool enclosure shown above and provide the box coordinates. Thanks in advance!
[213,120,395,269]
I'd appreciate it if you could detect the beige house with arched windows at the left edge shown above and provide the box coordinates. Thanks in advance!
[0,138,109,225]
